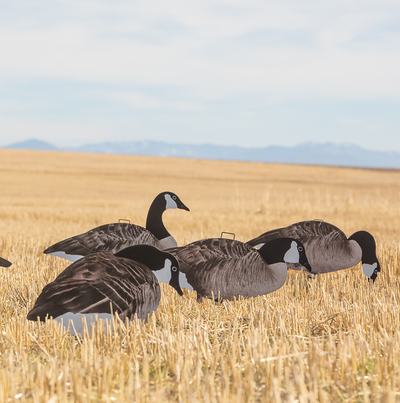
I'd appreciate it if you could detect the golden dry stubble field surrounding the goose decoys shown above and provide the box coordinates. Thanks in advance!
[0,150,400,403]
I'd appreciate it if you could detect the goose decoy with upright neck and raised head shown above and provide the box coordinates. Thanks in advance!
[43,192,190,262]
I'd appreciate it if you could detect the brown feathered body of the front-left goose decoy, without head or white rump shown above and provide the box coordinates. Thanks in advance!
[28,253,159,320]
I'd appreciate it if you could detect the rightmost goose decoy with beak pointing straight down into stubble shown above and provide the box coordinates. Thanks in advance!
[247,220,381,281]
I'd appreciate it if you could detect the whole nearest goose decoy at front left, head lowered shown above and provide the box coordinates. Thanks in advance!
[27,245,183,331]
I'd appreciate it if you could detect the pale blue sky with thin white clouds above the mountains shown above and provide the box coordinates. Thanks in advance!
[0,0,400,151]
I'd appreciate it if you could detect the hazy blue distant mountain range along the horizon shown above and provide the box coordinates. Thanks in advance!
[2,139,400,169]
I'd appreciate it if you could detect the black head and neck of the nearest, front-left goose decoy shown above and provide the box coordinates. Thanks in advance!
[114,245,183,296]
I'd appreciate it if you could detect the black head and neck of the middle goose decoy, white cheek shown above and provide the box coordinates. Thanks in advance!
[259,238,311,273]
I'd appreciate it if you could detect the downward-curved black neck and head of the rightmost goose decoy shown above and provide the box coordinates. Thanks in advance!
[349,231,381,282]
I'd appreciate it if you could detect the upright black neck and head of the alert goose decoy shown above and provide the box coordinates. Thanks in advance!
[146,192,190,240]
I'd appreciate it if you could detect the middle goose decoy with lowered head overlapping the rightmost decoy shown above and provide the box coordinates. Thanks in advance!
[168,238,311,302]
